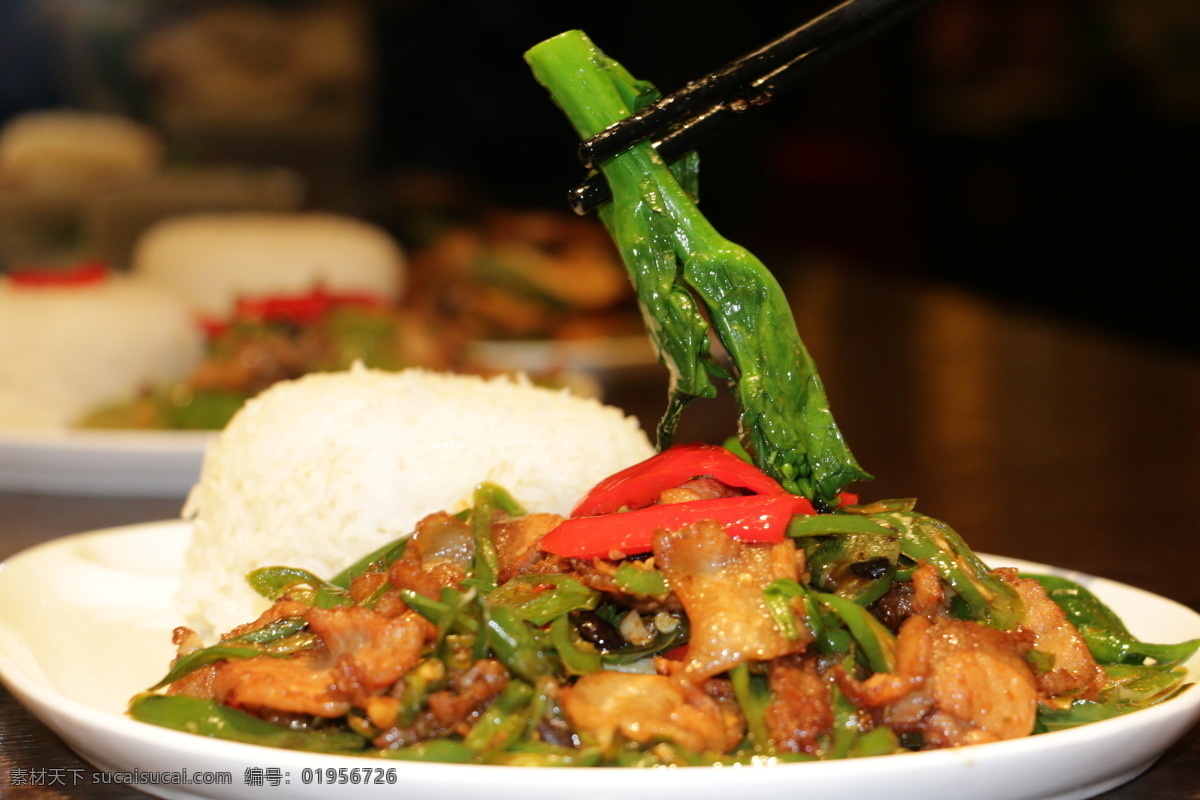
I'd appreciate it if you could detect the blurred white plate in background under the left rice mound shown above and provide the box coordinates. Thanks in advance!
[0,428,216,497]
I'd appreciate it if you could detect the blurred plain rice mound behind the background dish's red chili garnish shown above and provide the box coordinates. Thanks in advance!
[132,211,404,319]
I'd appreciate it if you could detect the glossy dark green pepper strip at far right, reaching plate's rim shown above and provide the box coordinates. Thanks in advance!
[1026,575,1200,667]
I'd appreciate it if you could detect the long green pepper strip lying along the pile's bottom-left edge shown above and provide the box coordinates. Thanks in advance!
[130,694,367,753]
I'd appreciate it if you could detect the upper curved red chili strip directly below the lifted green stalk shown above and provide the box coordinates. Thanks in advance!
[571,443,784,517]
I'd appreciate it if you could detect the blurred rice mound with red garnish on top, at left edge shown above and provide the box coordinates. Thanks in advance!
[0,276,204,428]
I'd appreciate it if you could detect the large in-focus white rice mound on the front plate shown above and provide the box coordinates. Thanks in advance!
[176,367,653,638]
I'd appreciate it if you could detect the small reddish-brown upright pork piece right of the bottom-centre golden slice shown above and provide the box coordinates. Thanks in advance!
[763,656,833,753]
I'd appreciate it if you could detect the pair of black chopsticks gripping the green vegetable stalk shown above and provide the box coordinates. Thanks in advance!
[568,0,931,215]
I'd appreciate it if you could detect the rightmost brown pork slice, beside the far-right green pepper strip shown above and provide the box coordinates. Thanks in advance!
[996,569,1108,700]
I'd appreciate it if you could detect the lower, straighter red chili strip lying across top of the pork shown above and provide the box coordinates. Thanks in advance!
[540,492,815,559]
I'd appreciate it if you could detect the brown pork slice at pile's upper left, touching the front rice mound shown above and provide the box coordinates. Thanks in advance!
[388,511,475,597]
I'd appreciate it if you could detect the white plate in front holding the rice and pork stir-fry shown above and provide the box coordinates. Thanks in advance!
[0,522,1200,800]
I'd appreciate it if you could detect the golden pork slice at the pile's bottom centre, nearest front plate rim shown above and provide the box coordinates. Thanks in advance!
[559,672,745,753]
